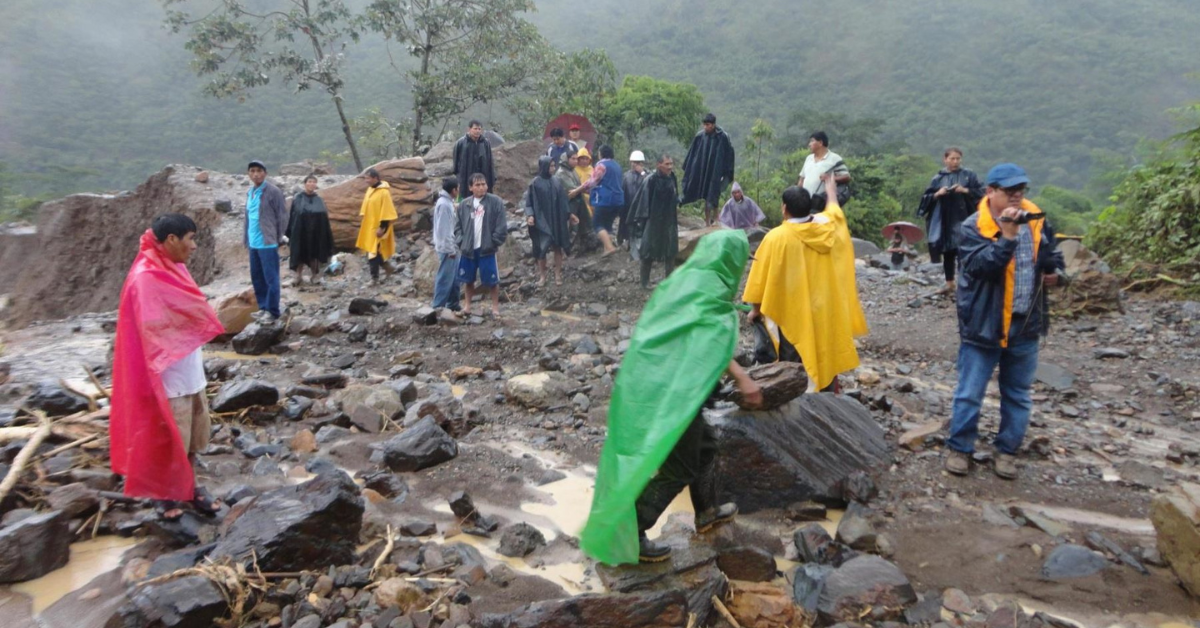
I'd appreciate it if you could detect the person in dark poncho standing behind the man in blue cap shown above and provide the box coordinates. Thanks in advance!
[917,146,984,293]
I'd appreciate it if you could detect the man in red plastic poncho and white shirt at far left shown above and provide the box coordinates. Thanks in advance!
[109,214,224,518]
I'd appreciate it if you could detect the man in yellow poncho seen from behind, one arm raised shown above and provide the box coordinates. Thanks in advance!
[742,170,866,391]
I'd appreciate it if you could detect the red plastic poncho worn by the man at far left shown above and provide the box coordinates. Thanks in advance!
[108,229,224,501]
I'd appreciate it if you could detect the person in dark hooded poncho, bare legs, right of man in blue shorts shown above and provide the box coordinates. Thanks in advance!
[522,155,580,286]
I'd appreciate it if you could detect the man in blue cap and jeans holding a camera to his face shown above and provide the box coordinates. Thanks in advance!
[946,163,1063,479]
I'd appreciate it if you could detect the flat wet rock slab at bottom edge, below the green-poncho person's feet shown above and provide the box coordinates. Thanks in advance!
[473,591,689,628]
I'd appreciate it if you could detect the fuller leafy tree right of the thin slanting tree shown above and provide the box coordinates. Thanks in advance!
[361,0,554,151]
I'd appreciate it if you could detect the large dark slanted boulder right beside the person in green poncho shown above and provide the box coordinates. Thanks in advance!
[709,393,892,513]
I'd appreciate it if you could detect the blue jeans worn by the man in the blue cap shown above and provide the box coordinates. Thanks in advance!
[947,329,1039,454]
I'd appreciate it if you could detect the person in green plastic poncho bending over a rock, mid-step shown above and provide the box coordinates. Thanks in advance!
[580,229,762,564]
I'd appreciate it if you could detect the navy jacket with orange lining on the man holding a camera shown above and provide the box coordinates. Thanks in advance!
[958,198,1064,347]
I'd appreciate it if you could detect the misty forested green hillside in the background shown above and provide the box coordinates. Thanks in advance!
[0,0,1200,195]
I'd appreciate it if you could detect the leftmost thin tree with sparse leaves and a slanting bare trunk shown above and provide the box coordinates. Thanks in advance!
[162,0,362,171]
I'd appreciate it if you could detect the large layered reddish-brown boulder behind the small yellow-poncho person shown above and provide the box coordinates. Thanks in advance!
[320,157,434,249]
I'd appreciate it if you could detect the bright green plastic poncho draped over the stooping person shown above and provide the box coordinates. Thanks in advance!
[580,229,750,564]
